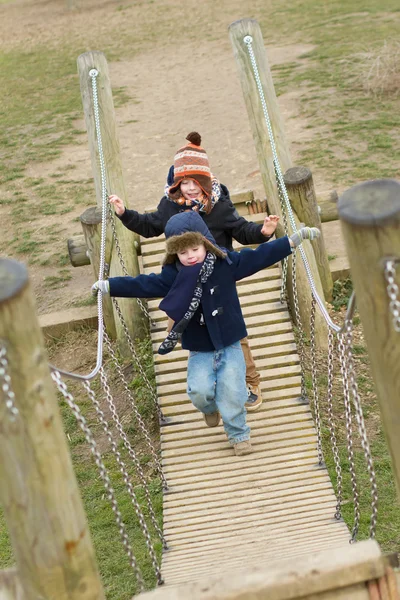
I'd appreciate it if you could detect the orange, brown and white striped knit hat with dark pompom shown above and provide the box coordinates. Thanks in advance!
[168,131,212,200]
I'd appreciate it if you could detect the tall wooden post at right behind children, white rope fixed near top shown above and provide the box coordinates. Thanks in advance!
[229,19,328,348]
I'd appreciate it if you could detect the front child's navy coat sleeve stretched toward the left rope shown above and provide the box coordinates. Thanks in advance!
[108,265,178,298]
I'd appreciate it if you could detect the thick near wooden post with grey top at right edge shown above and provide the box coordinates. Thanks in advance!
[338,179,400,497]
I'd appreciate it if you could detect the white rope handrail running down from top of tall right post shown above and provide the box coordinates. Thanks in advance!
[243,35,340,332]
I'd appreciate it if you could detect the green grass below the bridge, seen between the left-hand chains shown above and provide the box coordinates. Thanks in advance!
[0,330,162,600]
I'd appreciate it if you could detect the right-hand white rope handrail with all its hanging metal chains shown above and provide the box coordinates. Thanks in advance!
[243,35,378,541]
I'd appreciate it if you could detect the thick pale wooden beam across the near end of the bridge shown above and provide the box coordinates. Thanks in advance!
[146,540,385,600]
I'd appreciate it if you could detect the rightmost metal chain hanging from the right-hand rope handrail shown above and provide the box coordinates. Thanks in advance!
[346,321,378,538]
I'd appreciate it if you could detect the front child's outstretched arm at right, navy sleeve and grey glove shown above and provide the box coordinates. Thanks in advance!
[233,227,320,281]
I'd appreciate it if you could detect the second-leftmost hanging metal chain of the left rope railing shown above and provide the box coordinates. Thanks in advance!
[83,381,164,585]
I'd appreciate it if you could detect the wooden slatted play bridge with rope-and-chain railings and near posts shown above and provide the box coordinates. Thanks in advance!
[0,16,400,600]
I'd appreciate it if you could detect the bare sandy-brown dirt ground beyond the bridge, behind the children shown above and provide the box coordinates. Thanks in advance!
[0,0,329,313]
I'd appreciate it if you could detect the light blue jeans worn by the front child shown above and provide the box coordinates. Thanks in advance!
[187,342,250,444]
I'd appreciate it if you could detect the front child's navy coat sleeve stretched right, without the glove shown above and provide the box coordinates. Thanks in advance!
[228,236,292,281]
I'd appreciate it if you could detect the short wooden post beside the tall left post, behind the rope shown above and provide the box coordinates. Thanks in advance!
[79,206,117,339]
